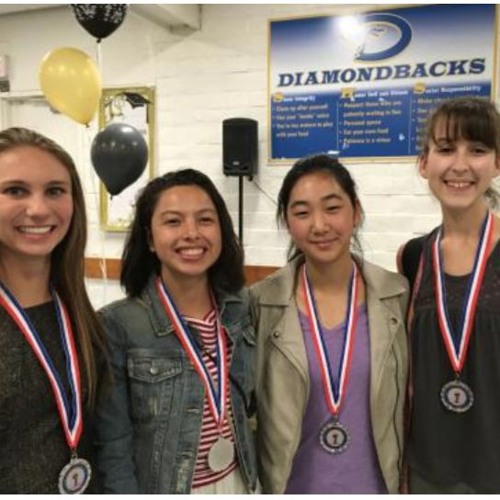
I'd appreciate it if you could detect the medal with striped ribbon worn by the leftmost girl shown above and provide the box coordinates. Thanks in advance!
[0,283,92,493]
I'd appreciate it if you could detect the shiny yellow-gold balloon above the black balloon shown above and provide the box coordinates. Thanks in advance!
[38,47,102,125]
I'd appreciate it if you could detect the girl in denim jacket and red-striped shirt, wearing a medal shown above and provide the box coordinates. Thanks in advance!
[97,169,256,494]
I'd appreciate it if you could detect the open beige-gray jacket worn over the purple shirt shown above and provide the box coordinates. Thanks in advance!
[251,262,408,493]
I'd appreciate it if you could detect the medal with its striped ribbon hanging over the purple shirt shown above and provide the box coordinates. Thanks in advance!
[302,264,359,453]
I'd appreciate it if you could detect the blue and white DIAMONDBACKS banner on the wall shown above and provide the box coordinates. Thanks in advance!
[269,4,496,160]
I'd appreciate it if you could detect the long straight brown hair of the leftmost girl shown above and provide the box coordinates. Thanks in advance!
[0,127,104,405]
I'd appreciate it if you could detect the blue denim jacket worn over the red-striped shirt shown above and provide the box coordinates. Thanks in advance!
[97,276,257,493]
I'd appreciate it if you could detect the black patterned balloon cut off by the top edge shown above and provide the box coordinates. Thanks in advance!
[71,3,127,42]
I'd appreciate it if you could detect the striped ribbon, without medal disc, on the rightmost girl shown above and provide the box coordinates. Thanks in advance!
[432,211,494,373]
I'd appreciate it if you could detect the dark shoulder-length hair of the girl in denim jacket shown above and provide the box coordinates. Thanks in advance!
[120,168,245,297]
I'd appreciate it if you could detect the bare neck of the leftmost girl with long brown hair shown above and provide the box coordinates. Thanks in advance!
[0,258,51,308]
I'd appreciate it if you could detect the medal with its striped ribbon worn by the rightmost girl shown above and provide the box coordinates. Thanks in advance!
[432,211,494,413]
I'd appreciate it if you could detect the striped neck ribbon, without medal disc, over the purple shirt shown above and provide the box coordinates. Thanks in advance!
[302,264,359,416]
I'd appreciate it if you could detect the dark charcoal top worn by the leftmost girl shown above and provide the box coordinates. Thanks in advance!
[0,302,96,493]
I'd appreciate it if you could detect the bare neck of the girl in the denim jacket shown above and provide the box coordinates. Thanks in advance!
[162,272,212,319]
